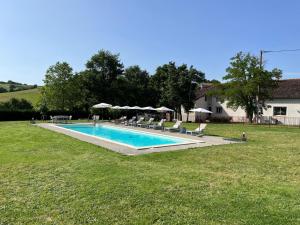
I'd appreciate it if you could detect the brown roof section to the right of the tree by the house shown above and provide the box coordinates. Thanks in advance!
[272,78,300,99]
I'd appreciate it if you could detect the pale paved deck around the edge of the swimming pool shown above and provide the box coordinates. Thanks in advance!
[37,122,241,155]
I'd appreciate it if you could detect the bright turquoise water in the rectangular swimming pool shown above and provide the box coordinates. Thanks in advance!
[60,124,190,148]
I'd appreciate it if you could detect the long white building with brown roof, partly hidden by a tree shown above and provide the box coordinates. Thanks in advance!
[182,78,300,125]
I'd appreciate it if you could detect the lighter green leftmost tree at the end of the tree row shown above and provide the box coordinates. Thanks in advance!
[42,62,78,111]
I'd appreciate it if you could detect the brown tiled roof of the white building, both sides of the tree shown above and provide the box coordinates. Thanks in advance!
[196,78,300,99]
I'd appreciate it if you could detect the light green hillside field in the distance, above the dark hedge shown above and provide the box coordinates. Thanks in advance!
[0,88,41,106]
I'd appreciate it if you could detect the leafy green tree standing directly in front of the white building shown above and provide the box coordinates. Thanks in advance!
[218,52,282,123]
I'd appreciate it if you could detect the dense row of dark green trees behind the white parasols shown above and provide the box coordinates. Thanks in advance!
[40,50,205,119]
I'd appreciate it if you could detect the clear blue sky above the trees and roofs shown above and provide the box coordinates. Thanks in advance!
[0,0,300,84]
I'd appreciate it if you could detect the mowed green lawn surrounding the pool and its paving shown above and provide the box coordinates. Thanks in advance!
[0,122,300,225]
